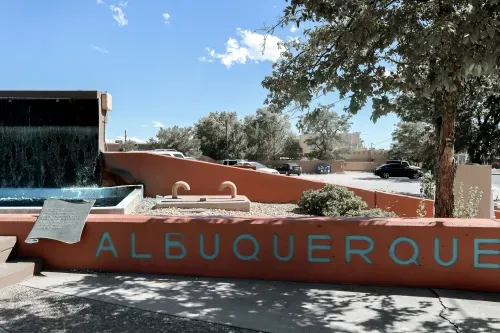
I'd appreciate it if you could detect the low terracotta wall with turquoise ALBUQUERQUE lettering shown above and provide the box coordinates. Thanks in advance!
[0,215,500,292]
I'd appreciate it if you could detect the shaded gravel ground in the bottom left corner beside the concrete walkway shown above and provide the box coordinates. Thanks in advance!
[0,285,258,333]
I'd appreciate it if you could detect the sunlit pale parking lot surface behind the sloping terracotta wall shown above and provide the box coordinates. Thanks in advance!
[300,172,420,195]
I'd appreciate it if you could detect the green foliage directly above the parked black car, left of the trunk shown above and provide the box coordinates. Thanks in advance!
[389,122,436,169]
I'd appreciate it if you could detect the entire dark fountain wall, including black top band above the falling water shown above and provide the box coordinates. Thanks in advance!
[0,93,101,188]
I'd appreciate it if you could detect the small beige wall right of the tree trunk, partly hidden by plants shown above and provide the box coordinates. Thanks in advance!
[454,165,493,219]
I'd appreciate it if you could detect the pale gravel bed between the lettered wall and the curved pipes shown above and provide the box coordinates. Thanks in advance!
[132,198,307,217]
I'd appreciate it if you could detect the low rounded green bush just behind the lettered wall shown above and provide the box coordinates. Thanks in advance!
[298,184,397,217]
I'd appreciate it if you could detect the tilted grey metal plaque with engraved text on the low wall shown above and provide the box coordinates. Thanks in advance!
[25,199,95,244]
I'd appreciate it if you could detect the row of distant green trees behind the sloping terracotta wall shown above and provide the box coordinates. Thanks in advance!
[118,105,351,161]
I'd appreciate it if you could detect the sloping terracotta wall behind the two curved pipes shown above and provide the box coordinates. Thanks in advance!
[103,152,375,208]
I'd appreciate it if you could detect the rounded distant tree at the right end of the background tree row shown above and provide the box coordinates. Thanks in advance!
[297,105,351,160]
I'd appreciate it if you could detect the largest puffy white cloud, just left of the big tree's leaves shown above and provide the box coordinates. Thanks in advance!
[202,28,284,68]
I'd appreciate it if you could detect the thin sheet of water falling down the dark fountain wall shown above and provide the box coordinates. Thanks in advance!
[0,126,101,188]
